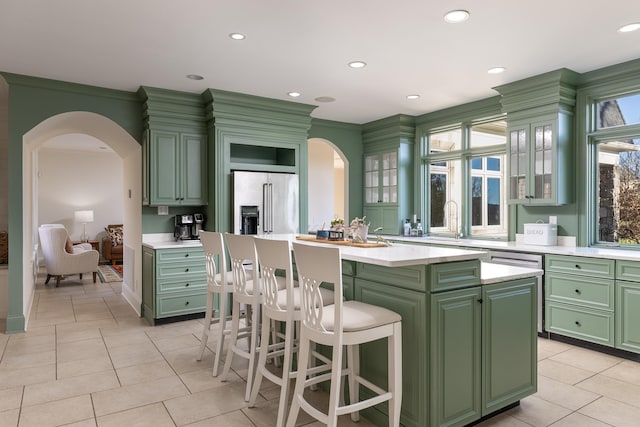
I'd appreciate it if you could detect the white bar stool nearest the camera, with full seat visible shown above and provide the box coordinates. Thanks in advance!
[287,242,402,427]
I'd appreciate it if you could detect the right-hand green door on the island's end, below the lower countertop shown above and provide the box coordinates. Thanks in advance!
[482,278,538,416]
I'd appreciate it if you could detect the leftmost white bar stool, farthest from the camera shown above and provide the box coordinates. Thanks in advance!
[196,230,233,377]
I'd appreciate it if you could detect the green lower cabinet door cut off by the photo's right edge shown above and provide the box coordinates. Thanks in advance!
[616,276,640,353]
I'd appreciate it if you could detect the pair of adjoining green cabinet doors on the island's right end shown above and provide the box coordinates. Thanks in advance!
[429,278,538,426]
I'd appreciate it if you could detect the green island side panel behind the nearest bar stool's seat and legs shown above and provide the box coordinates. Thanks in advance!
[355,278,428,427]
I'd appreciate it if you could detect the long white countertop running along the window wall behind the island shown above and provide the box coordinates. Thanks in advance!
[385,236,640,261]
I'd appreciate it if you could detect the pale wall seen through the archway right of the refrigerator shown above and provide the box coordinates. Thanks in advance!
[308,140,335,230]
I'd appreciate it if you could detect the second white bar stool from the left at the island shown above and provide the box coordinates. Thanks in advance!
[222,233,270,401]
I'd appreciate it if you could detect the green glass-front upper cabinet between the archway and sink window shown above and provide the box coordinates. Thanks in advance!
[362,115,415,235]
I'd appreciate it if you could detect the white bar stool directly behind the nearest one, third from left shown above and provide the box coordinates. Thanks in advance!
[249,238,334,427]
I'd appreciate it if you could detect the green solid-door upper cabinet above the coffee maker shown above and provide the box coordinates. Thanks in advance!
[139,87,208,206]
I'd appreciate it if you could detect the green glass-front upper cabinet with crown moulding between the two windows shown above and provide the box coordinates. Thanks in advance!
[495,69,576,206]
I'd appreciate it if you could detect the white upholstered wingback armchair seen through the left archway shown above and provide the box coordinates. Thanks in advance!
[38,224,100,286]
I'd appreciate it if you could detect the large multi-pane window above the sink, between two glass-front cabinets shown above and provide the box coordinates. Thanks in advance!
[422,120,508,238]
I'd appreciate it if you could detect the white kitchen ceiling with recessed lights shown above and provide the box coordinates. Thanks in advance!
[0,0,640,123]
